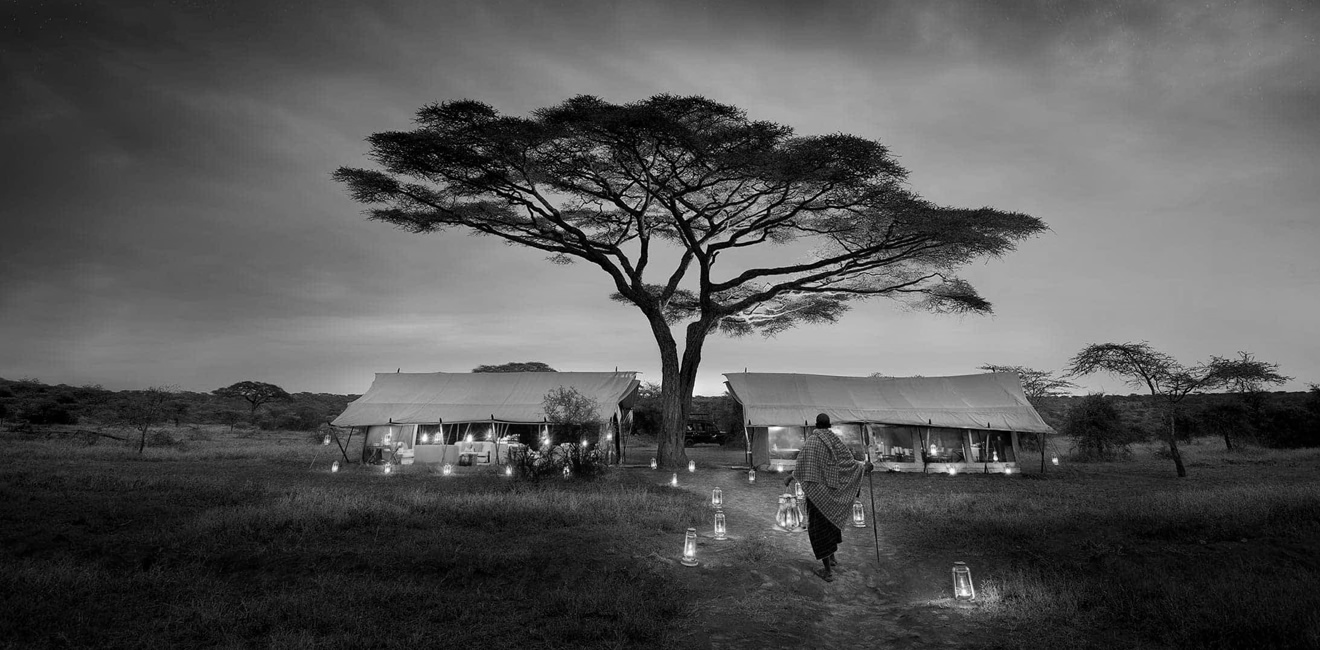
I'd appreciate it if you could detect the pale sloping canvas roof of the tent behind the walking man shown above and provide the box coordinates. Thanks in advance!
[725,373,1053,433]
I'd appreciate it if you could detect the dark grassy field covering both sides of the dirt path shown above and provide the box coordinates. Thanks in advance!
[0,428,1320,649]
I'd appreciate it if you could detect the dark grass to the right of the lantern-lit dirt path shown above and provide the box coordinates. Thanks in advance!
[884,440,1320,649]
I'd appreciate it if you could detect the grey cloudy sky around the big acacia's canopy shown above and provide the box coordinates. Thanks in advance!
[0,0,1320,394]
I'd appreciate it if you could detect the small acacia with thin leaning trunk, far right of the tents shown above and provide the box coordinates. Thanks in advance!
[1068,341,1287,477]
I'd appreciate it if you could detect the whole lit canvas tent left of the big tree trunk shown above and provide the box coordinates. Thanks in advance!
[331,373,639,465]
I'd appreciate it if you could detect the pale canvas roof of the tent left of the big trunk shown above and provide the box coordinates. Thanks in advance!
[331,373,639,427]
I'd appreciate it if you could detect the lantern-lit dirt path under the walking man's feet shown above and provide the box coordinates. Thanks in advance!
[640,447,987,649]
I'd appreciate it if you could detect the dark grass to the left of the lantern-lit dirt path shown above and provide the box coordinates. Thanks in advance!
[0,425,702,647]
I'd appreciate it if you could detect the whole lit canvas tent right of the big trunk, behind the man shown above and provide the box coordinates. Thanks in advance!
[725,373,1053,473]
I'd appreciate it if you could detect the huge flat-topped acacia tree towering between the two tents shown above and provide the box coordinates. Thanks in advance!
[334,95,1045,466]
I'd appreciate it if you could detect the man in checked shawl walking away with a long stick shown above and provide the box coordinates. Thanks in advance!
[784,414,871,583]
